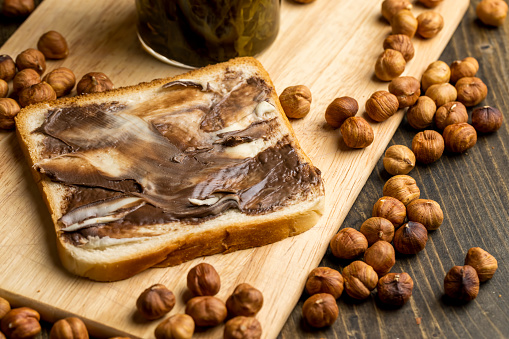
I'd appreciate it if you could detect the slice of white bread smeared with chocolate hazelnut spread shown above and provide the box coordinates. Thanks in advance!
[16,58,324,281]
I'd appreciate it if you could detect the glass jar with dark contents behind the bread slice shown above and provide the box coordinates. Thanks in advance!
[136,0,281,67]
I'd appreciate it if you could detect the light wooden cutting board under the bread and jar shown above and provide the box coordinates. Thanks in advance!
[0,0,468,338]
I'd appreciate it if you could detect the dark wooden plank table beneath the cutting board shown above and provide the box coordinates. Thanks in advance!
[0,0,509,339]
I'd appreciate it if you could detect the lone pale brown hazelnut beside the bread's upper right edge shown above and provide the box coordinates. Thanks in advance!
[279,85,311,119]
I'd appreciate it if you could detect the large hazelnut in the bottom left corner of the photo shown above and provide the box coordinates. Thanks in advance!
[1,307,41,339]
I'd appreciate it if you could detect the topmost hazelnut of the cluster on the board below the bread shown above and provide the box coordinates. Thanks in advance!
[187,263,221,295]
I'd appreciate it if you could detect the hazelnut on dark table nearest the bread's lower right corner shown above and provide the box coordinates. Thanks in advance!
[330,227,368,259]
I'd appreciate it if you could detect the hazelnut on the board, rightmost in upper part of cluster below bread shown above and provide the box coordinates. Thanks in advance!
[226,283,263,317]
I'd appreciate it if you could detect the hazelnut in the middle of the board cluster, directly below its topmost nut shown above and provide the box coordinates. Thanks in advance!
[186,295,228,327]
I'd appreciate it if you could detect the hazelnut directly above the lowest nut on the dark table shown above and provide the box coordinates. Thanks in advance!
[306,267,344,299]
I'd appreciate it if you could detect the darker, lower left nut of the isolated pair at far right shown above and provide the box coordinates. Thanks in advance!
[444,265,479,301]
